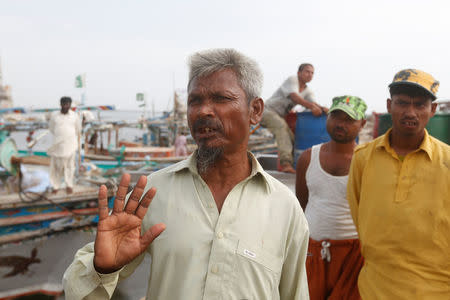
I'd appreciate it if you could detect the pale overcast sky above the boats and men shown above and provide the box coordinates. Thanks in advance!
[0,0,450,113]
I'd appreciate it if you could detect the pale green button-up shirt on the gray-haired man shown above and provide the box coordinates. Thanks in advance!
[63,154,309,300]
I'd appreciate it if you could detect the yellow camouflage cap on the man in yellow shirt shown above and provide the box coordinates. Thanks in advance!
[389,69,439,100]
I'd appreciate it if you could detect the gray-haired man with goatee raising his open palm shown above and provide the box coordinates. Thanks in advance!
[63,49,309,300]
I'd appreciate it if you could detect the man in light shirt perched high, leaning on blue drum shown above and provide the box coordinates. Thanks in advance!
[261,63,328,173]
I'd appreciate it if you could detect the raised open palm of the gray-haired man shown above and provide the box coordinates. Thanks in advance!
[94,174,166,274]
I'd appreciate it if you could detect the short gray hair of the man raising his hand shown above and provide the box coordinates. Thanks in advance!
[188,49,263,102]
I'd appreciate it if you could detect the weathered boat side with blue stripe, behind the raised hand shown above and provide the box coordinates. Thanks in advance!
[0,185,115,245]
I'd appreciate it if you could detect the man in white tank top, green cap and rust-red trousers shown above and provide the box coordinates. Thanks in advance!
[296,96,367,300]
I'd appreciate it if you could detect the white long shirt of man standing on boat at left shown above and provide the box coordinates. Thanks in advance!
[47,110,81,157]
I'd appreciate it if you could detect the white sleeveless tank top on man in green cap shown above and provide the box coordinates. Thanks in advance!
[305,144,358,241]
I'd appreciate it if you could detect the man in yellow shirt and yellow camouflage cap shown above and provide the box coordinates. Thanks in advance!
[347,69,450,300]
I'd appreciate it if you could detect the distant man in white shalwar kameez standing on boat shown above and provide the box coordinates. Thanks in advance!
[47,97,81,193]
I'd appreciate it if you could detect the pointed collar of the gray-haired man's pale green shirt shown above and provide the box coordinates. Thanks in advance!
[171,151,274,193]
